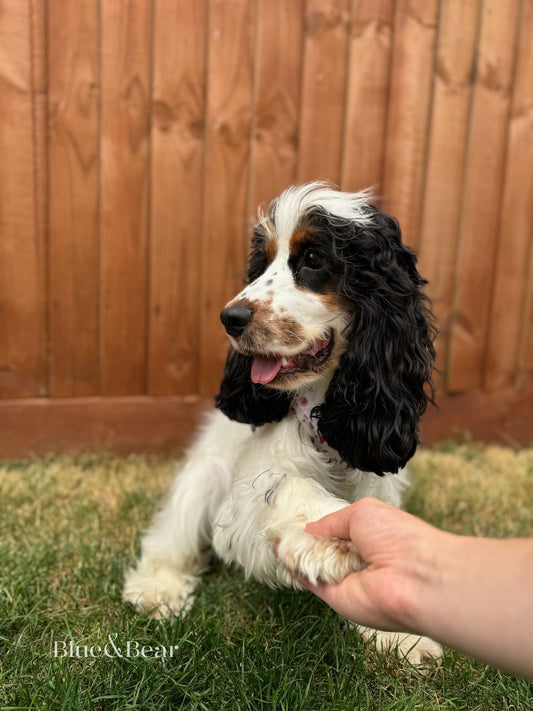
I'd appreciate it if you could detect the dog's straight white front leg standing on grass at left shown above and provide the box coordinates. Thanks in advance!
[123,411,250,617]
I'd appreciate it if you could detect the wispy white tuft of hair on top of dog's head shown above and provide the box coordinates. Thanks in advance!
[269,182,372,253]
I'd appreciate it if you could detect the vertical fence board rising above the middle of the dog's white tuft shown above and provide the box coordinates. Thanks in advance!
[298,0,350,184]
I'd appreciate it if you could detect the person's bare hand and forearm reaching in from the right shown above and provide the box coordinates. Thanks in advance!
[302,498,533,679]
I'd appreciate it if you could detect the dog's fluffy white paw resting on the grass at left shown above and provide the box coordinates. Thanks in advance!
[122,565,199,619]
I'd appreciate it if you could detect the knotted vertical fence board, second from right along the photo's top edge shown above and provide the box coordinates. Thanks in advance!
[448,0,519,391]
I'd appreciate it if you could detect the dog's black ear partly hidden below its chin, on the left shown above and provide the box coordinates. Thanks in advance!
[215,348,293,427]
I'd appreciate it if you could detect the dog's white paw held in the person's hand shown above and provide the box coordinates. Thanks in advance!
[277,527,365,589]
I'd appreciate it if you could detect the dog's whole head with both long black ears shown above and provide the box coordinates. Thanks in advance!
[217,183,435,474]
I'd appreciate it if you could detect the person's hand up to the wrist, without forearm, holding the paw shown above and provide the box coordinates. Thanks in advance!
[302,498,449,632]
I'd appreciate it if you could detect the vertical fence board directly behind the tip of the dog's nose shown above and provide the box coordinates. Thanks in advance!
[200,0,255,394]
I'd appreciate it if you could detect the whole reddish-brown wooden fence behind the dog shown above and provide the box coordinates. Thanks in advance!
[0,0,533,456]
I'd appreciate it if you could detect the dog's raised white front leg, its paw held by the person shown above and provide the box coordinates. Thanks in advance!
[213,471,363,588]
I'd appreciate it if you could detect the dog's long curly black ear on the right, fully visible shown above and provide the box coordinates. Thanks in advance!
[314,208,435,475]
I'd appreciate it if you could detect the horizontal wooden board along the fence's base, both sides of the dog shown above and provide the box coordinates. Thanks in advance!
[0,374,533,458]
